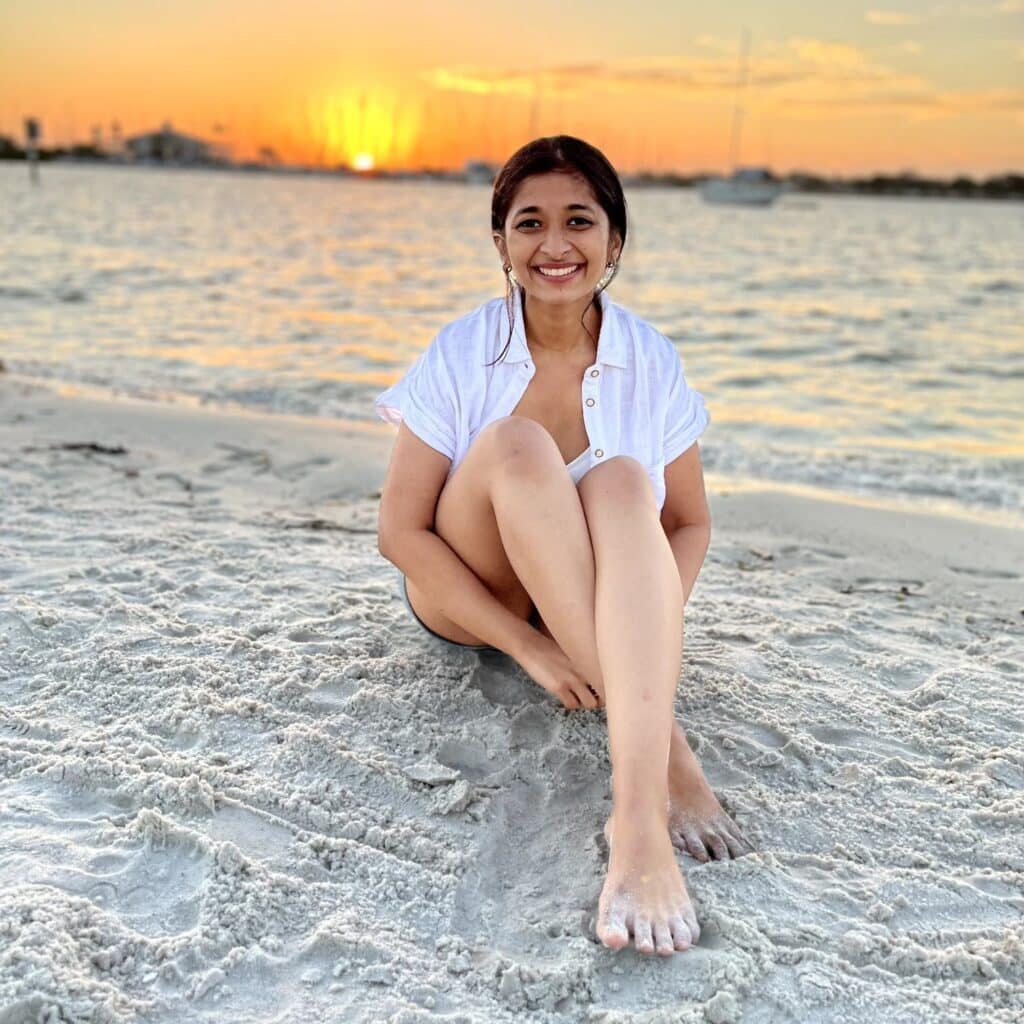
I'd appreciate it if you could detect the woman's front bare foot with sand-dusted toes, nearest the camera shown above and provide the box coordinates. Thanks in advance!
[597,811,700,956]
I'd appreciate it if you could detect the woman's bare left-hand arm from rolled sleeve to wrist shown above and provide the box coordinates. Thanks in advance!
[377,425,537,660]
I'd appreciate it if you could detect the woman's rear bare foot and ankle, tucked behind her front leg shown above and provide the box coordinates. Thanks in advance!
[669,723,754,860]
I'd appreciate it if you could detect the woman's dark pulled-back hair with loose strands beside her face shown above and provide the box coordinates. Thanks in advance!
[488,135,626,366]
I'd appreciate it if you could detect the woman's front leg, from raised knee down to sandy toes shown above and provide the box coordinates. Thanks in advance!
[569,458,699,954]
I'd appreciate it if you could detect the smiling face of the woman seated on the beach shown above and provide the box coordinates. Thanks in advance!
[495,171,621,302]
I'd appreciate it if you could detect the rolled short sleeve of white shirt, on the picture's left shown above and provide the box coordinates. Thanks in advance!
[374,339,456,459]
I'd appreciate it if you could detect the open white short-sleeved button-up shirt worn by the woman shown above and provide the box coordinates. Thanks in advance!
[374,288,710,509]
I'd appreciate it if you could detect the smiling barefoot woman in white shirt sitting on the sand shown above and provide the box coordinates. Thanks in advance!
[377,135,751,955]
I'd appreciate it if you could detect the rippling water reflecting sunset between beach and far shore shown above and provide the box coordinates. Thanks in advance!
[0,163,1024,523]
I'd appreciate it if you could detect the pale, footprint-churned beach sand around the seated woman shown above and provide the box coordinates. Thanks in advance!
[0,375,1024,1024]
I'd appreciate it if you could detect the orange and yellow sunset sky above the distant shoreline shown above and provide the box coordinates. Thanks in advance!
[0,0,1024,175]
